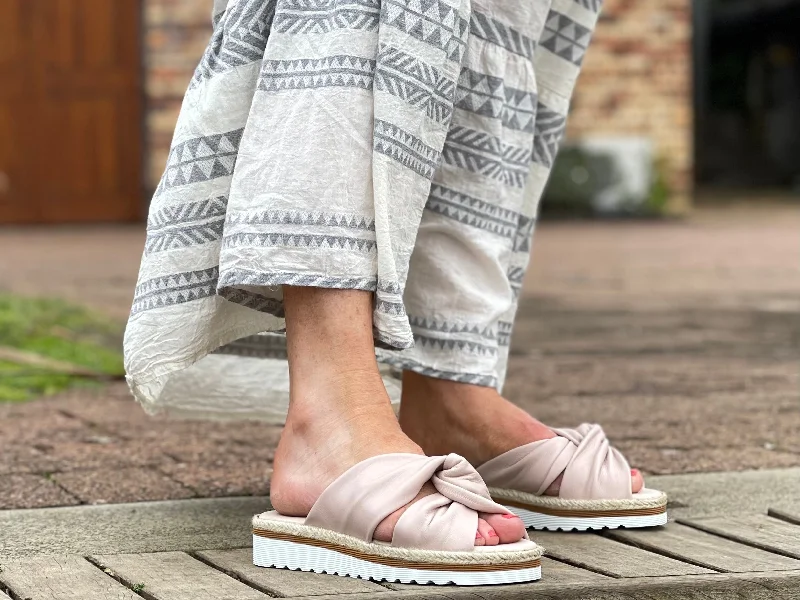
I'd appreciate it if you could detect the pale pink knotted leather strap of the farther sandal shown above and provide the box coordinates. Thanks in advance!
[478,423,633,500]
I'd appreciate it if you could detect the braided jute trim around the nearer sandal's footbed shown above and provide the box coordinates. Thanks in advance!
[253,515,544,566]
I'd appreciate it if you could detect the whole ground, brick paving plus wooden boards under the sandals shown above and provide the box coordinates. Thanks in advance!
[0,208,800,600]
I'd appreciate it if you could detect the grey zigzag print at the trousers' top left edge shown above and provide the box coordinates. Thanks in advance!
[189,0,276,89]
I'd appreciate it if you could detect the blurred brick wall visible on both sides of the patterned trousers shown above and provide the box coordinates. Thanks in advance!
[144,0,693,209]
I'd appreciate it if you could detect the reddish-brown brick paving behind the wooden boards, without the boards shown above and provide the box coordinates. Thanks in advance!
[0,204,800,509]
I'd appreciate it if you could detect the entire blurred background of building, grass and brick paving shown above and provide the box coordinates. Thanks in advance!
[0,0,800,508]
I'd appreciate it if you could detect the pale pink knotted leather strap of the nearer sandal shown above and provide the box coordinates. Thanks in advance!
[305,454,508,551]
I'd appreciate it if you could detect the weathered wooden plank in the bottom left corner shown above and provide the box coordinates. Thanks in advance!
[0,556,141,600]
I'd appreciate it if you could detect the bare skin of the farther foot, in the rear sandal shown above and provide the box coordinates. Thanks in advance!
[400,371,644,496]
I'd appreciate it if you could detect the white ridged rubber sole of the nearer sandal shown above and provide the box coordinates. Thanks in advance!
[253,535,542,585]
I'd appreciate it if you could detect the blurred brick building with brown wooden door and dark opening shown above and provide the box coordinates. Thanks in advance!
[6,0,800,225]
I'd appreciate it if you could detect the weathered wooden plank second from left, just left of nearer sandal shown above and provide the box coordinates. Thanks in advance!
[92,552,265,600]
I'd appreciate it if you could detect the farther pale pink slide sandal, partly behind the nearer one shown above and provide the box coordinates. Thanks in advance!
[478,424,667,531]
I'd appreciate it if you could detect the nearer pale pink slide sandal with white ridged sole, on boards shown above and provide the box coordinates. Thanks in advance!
[253,454,543,585]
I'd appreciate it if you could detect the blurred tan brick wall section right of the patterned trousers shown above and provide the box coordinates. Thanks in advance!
[567,0,693,211]
